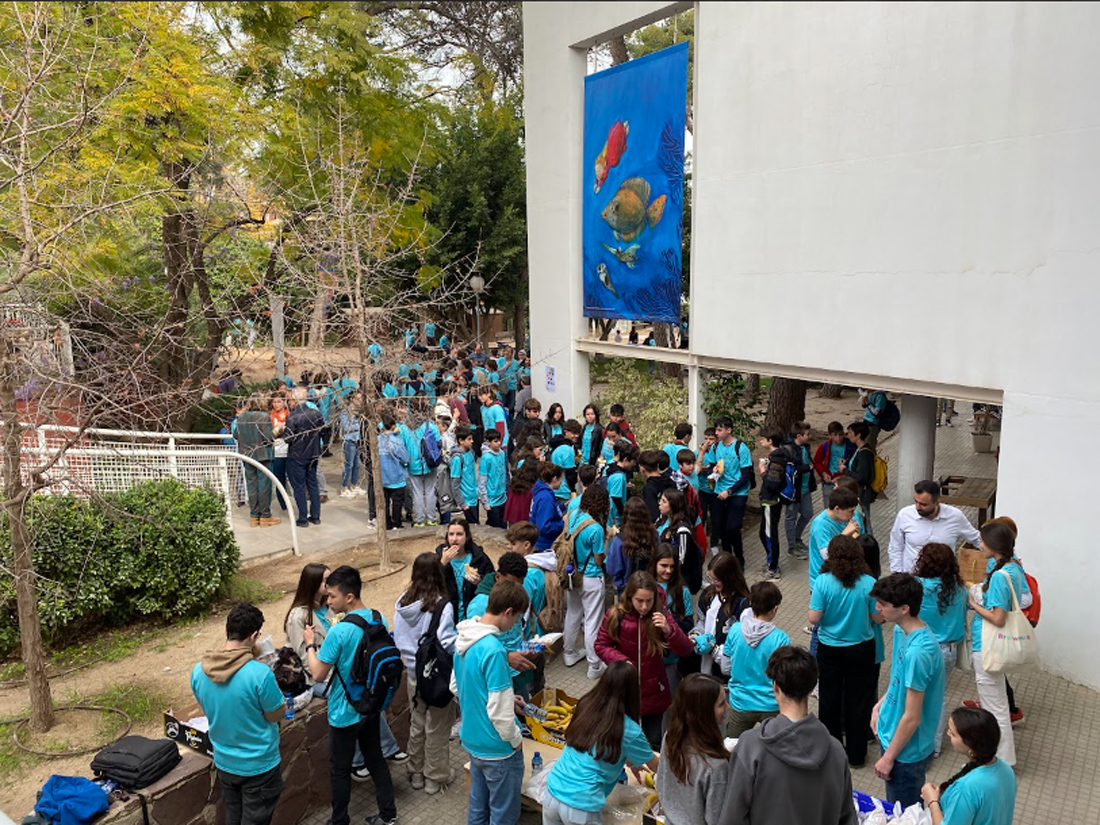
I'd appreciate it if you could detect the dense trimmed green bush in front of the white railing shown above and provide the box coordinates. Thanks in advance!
[0,480,240,653]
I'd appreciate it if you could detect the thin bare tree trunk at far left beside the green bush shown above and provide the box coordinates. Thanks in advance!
[0,338,54,733]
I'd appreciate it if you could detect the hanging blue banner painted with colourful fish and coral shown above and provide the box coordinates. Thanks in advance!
[583,43,688,323]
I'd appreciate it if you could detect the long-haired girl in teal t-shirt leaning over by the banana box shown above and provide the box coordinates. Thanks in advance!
[542,661,657,825]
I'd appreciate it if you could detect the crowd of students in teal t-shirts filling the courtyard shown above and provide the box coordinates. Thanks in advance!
[196,376,1027,825]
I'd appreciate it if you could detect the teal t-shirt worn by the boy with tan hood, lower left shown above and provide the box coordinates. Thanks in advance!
[191,659,285,777]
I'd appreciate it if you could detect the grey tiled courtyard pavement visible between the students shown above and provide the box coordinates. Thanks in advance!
[306,415,1100,825]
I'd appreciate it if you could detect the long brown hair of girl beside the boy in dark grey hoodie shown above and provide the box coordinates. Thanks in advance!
[661,673,729,784]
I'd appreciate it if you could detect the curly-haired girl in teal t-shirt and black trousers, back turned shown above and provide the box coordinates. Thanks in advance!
[809,536,881,768]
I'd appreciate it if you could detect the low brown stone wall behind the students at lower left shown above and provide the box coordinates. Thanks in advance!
[101,682,409,825]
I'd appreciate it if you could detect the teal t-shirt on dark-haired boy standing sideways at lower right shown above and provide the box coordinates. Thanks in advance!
[878,626,944,762]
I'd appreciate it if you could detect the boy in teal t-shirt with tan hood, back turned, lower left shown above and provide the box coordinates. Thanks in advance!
[191,604,286,825]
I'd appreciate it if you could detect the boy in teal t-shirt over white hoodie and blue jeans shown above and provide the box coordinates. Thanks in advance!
[451,581,529,823]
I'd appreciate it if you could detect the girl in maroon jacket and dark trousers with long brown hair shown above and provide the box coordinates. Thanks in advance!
[598,572,692,750]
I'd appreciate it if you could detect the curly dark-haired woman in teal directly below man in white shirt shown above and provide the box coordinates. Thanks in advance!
[913,541,967,756]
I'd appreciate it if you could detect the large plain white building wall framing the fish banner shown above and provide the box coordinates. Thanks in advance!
[525,2,1100,688]
